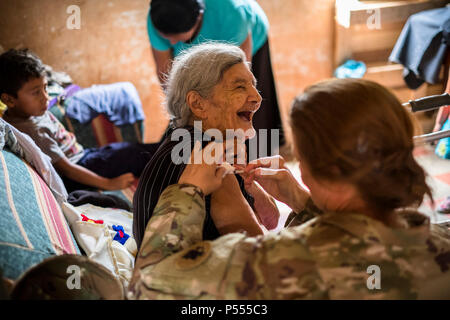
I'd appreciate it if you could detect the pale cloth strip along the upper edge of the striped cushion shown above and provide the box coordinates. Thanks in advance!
[0,118,67,204]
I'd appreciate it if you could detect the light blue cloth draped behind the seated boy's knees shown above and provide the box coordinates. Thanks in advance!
[66,82,145,126]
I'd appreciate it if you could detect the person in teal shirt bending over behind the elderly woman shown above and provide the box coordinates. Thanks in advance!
[147,0,285,157]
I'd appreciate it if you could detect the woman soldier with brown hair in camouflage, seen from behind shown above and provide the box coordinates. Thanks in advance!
[129,79,450,299]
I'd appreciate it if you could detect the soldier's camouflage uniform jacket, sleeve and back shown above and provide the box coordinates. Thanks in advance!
[128,185,450,299]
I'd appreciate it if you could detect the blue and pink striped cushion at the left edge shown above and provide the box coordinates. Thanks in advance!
[0,150,80,280]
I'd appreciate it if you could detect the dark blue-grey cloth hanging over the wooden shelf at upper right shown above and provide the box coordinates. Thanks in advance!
[389,6,450,89]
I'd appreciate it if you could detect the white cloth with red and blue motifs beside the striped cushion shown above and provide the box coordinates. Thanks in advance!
[62,202,137,288]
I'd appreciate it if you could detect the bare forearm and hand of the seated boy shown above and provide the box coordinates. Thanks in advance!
[53,157,134,190]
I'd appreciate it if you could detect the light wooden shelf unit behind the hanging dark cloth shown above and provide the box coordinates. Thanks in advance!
[334,0,448,132]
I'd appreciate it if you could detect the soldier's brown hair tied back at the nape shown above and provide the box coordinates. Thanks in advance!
[290,79,432,213]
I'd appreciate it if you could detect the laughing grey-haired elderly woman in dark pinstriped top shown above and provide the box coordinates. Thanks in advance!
[133,43,279,248]
